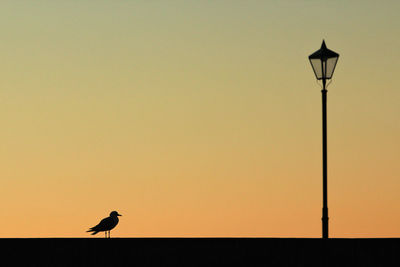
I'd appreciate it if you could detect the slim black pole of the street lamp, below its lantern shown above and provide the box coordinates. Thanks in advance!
[321,79,329,238]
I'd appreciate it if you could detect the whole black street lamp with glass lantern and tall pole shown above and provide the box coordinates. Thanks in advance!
[308,41,339,238]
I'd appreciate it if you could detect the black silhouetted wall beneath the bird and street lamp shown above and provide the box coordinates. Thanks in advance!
[0,238,400,267]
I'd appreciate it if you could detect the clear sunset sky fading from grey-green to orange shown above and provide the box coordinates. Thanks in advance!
[0,0,400,237]
